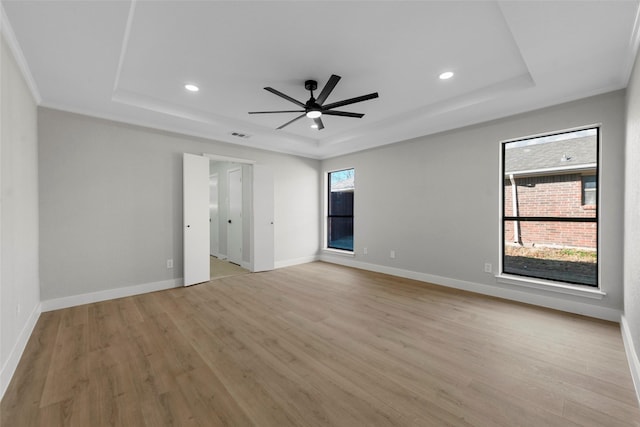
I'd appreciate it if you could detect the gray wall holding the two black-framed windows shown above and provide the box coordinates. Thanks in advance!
[322,91,625,316]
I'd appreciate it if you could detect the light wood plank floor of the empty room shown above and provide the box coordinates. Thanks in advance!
[0,263,640,427]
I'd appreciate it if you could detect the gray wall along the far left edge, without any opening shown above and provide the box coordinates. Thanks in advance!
[0,36,40,396]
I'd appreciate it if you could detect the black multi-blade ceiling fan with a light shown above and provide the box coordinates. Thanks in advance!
[249,74,378,130]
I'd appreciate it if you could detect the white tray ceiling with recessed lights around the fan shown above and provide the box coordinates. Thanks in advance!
[2,0,640,158]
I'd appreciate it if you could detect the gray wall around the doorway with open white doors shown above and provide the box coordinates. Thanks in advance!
[38,108,320,300]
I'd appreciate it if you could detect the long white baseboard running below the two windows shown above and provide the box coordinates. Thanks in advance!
[320,254,622,323]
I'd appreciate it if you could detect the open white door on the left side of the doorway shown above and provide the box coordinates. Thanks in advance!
[182,153,211,286]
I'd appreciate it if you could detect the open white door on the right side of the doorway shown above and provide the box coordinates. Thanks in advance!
[251,164,274,272]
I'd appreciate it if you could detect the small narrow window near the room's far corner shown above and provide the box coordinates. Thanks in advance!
[327,169,355,252]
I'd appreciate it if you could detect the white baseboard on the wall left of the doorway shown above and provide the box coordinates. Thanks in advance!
[42,278,184,312]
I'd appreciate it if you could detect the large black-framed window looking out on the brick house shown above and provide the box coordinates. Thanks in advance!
[502,128,599,287]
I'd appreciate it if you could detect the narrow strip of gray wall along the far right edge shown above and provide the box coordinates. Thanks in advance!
[624,48,640,368]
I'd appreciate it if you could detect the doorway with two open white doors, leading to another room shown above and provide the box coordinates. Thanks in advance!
[183,153,275,286]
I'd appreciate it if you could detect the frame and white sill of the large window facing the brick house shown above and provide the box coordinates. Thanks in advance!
[496,124,606,290]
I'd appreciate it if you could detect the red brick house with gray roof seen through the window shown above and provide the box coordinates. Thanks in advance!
[504,136,597,249]
